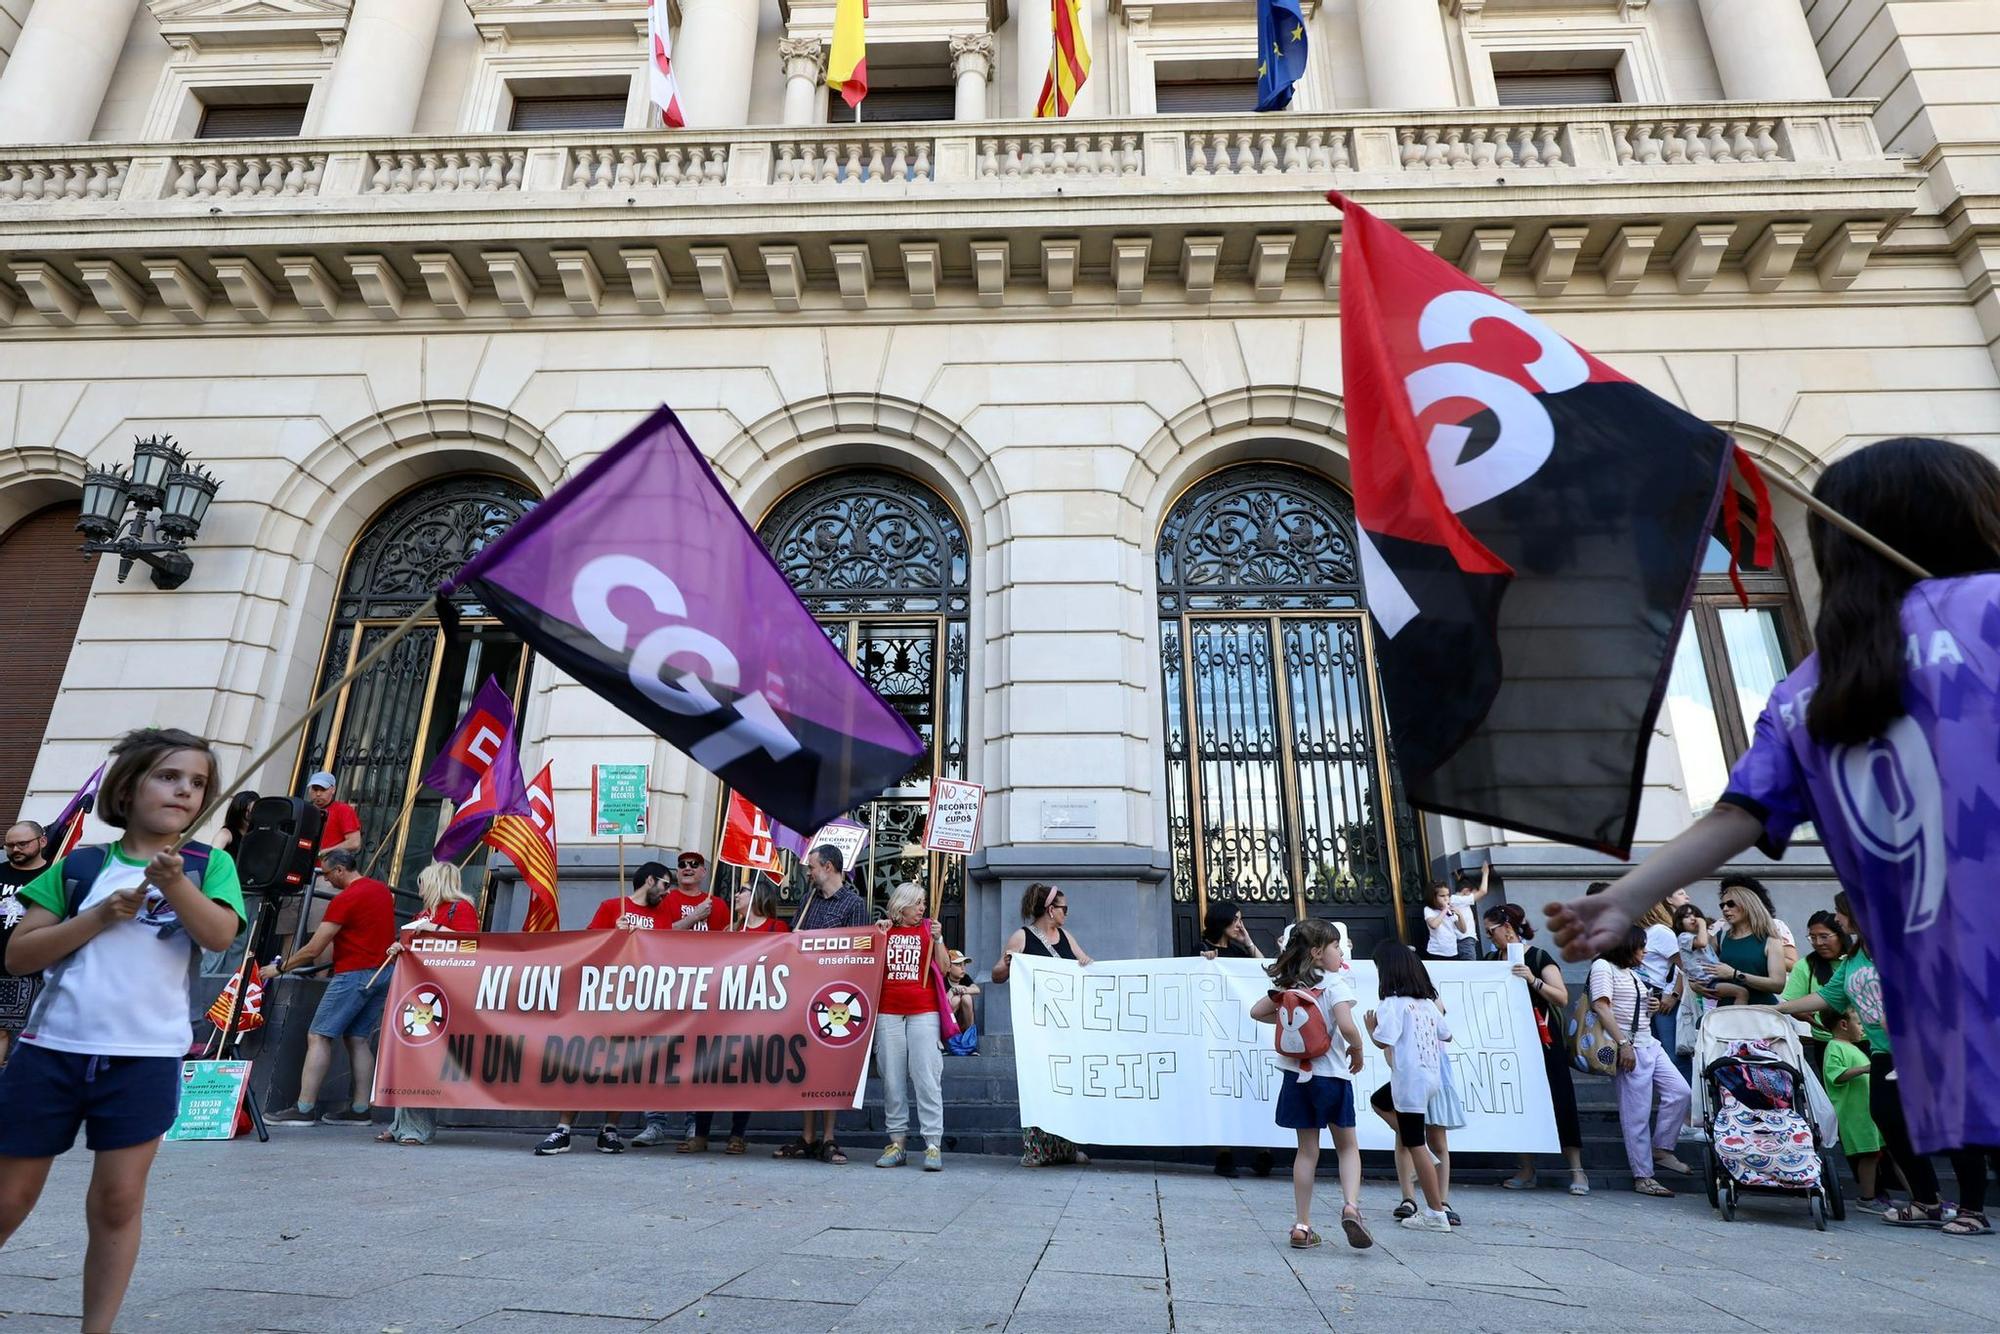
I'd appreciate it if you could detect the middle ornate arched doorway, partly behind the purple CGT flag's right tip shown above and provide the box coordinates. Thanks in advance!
[740,470,972,942]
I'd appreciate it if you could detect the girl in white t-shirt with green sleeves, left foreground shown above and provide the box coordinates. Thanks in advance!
[0,728,244,1330]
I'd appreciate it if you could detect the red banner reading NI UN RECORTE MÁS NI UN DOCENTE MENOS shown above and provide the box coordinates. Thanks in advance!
[374,928,882,1112]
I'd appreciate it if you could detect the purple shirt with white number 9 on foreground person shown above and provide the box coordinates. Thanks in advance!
[1722,574,2000,1152]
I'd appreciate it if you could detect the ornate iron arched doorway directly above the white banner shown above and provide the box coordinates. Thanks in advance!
[1156,464,1424,954]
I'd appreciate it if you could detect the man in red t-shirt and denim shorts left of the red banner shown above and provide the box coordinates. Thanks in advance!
[264,850,396,1124]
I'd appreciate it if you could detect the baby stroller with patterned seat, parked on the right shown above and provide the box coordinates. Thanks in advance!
[1694,1006,1848,1232]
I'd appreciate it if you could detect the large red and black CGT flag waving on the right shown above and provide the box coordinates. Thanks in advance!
[1328,194,1762,856]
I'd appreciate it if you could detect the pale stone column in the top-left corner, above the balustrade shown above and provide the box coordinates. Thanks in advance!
[0,0,138,144]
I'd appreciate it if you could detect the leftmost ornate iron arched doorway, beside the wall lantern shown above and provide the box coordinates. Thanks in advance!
[292,474,536,888]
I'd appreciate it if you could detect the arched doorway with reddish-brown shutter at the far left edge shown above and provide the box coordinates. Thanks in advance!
[0,500,98,824]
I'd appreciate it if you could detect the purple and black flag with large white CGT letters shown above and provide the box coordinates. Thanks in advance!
[438,408,924,830]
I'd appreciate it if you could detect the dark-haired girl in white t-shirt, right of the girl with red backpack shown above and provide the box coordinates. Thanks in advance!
[1368,940,1452,1232]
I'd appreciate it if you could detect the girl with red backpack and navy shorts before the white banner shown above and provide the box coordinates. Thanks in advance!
[1250,920,1374,1250]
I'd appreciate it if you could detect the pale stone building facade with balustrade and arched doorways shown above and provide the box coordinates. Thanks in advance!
[0,0,2000,980]
